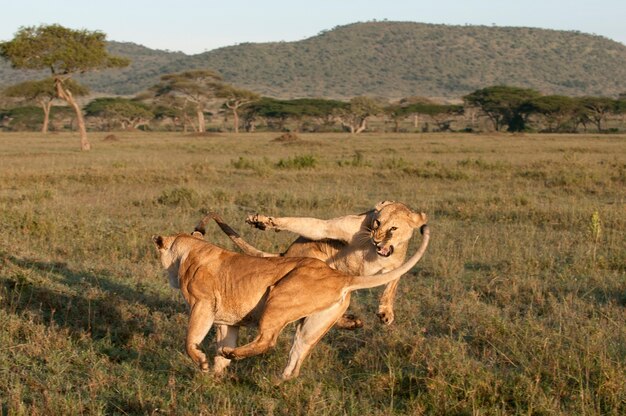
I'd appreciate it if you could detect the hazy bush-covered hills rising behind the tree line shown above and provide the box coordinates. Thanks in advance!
[0,22,626,98]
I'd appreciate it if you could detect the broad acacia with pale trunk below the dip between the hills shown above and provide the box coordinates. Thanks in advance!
[151,69,222,133]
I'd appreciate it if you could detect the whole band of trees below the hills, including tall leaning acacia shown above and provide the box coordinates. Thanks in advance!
[0,25,626,143]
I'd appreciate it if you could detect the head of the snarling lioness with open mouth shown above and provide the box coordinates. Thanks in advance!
[370,201,427,257]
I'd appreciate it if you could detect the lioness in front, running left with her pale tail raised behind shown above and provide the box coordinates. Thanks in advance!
[153,221,430,380]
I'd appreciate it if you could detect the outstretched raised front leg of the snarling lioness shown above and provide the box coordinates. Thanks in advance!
[246,214,365,242]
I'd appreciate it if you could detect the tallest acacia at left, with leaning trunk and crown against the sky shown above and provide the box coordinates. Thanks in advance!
[0,25,129,150]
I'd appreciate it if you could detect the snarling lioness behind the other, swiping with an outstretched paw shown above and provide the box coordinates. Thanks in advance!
[196,201,424,329]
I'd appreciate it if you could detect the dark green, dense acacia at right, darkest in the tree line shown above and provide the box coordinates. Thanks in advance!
[463,85,540,131]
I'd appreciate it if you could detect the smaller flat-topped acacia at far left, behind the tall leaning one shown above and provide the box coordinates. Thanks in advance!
[4,78,89,134]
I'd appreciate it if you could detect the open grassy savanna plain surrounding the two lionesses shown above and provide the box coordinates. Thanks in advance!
[0,133,626,415]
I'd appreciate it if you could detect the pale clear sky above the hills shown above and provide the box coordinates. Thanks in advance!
[0,0,626,54]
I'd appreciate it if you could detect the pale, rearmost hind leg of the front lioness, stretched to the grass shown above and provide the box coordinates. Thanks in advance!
[282,295,350,380]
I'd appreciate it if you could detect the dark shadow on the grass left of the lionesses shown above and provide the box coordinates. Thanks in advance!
[0,253,185,361]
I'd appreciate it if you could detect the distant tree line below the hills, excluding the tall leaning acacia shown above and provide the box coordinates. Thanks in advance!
[0,84,626,134]
